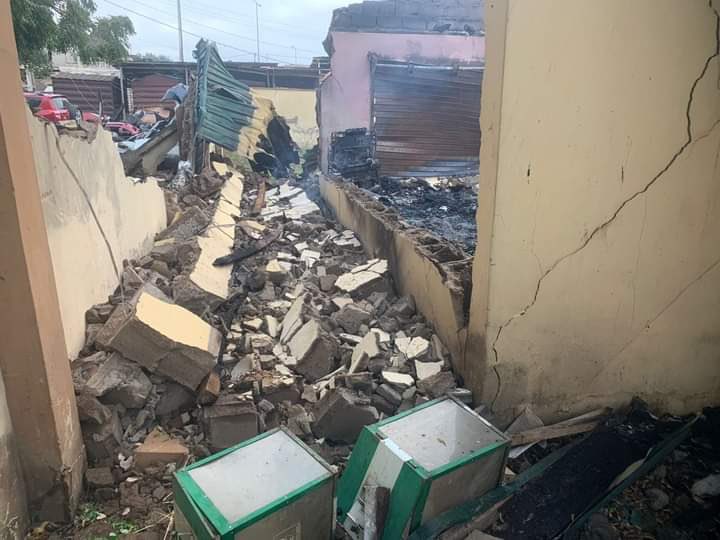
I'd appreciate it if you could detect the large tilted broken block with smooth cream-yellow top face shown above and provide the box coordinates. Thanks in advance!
[96,289,221,390]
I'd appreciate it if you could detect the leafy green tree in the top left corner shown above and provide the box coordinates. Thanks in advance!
[10,0,135,76]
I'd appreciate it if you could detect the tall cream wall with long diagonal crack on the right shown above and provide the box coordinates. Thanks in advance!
[463,0,720,417]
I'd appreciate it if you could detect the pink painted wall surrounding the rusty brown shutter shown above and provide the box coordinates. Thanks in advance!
[320,32,485,172]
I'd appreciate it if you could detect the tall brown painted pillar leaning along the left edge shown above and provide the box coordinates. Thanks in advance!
[0,0,85,521]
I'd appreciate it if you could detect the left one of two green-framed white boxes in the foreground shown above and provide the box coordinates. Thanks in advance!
[173,428,335,540]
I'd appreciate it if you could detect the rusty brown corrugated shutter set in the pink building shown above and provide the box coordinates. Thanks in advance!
[373,63,483,177]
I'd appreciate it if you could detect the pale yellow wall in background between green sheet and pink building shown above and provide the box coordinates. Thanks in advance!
[253,88,320,150]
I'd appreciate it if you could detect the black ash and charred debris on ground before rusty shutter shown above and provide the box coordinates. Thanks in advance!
[369,176,477,255]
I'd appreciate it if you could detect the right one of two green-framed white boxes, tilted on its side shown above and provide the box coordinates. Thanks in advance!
[337,397,510,540]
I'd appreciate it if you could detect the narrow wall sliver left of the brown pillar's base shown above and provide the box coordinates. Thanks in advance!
[0,373,28,539]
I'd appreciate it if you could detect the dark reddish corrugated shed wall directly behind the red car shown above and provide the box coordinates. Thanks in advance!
[52,72,122,116]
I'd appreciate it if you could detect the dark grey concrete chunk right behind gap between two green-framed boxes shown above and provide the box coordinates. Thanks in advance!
[313,388,379,443]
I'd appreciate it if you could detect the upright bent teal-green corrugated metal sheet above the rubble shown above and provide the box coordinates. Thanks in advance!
[195,40,256,150]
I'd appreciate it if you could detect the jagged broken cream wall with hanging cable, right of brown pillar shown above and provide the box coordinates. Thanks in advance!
[27,112,166,359]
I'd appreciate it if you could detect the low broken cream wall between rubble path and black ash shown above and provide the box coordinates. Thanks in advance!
[320,177,471,376]
